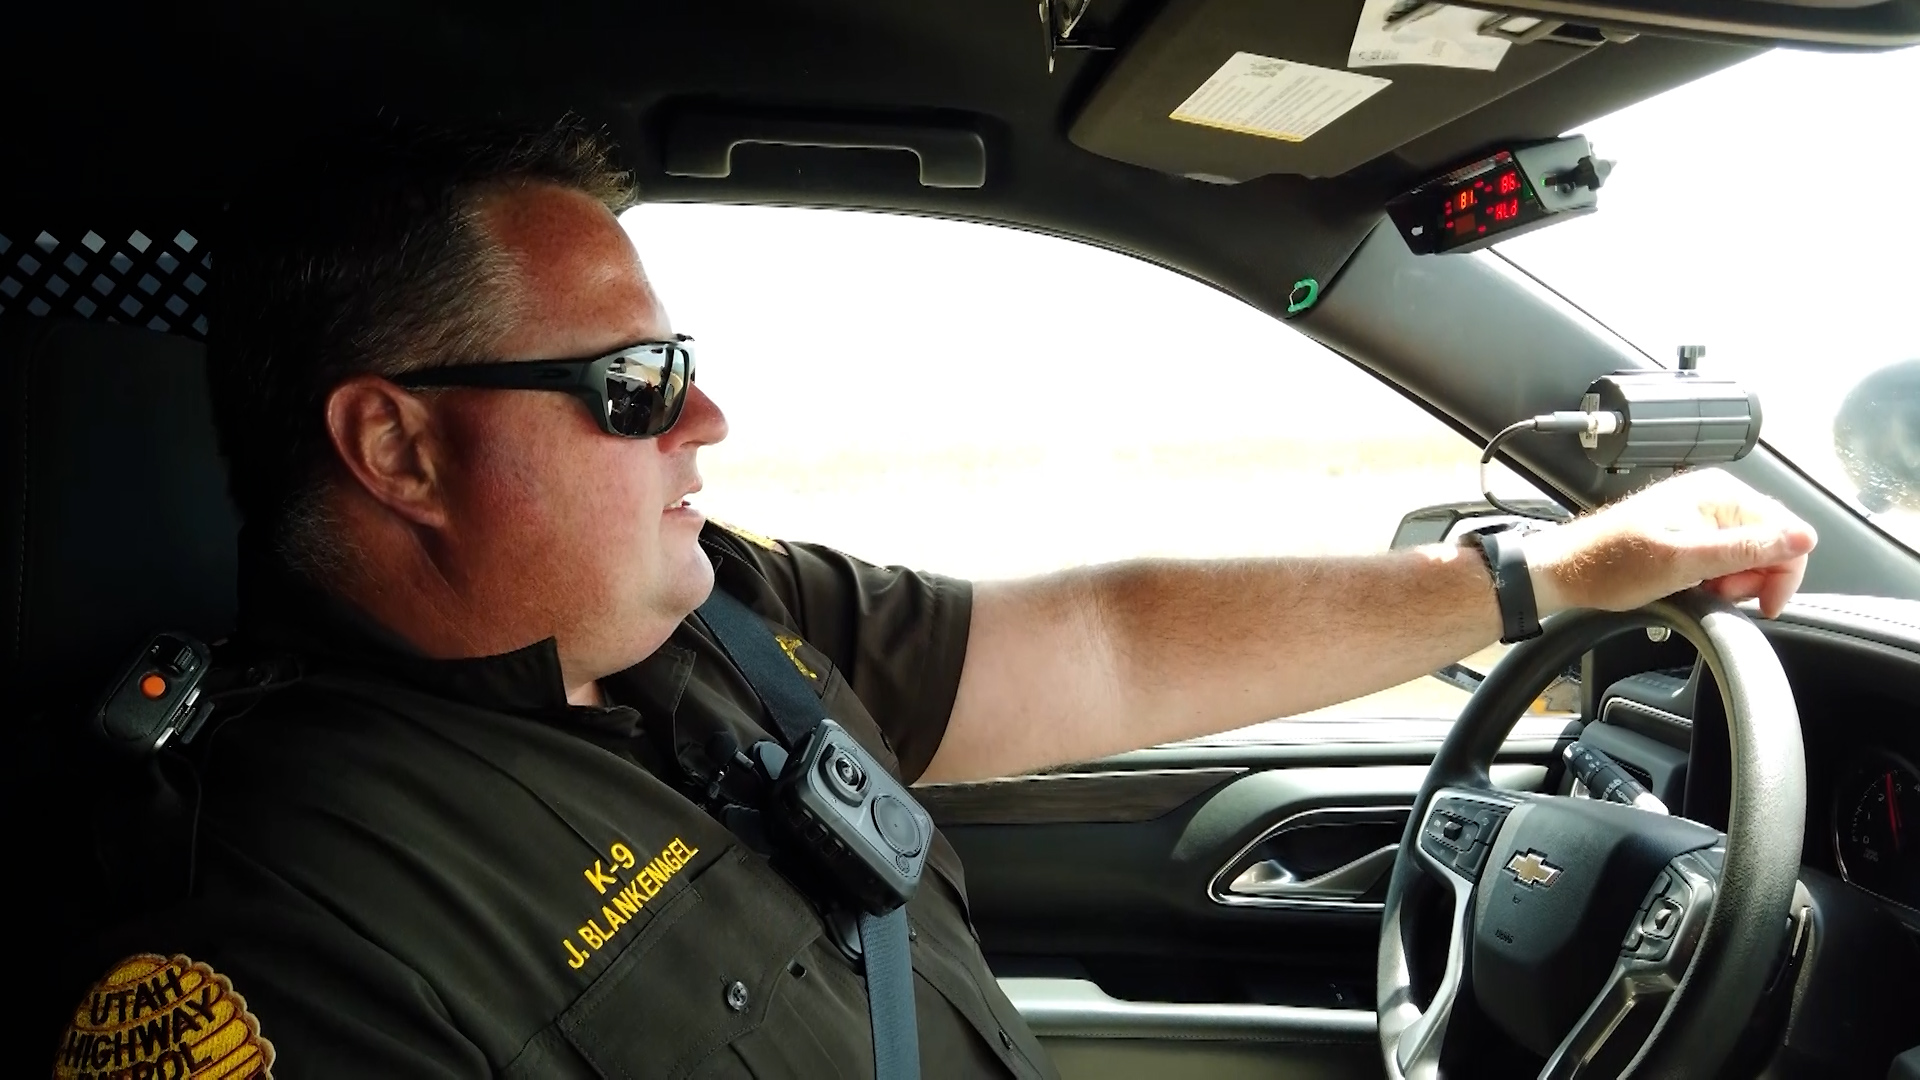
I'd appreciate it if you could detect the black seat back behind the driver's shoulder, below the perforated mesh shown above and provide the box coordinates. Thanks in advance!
[0,311,238,1057]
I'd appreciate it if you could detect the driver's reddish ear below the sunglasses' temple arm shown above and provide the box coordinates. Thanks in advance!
[326,375,447,528]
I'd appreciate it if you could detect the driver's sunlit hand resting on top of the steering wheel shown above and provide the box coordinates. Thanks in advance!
[1526,469,1816,619]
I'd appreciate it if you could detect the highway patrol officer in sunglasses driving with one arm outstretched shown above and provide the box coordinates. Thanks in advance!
[54,125,1814,1078]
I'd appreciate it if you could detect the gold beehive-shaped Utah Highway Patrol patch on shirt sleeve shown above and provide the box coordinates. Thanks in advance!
[54,953,273,1080]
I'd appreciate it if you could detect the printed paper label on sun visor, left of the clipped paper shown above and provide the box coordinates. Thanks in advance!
[1169,52,1390,142]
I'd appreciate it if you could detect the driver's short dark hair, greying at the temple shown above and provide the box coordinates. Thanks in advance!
[207,117,636,577]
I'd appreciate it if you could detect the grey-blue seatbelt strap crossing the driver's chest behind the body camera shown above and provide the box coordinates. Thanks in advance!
[699,588,920,1080]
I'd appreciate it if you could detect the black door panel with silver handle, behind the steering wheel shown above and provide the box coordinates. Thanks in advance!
[927,717,1576,1080]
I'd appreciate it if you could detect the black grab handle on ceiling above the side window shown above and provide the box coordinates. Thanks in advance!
[662,110,987,188]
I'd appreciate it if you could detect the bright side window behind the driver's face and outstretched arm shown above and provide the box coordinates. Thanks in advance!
[624,204,1538,717]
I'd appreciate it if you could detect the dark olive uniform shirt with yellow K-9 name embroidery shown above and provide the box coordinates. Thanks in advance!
[54,527,1054,1078]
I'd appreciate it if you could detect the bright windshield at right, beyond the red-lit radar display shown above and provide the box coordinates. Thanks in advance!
[1498,48,1920,550]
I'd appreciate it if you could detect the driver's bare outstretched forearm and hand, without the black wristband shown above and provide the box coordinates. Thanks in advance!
[924,471,1814,780]
